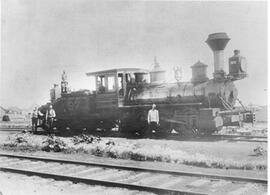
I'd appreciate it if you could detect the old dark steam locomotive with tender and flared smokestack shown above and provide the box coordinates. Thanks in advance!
[41,33,253,136]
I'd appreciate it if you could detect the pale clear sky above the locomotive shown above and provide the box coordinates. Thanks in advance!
[0,0,267,108]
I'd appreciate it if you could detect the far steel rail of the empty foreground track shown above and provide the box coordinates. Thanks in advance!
[0,153,268,184]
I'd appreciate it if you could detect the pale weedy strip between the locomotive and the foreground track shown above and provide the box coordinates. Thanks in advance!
[1,123,267,170]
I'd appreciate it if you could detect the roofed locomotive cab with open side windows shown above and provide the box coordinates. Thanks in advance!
[86,68,149,108]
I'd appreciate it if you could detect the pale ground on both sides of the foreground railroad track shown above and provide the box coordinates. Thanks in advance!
[0,121,267,195]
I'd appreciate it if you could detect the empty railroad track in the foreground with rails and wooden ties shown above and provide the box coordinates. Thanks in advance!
[0,154,267,195]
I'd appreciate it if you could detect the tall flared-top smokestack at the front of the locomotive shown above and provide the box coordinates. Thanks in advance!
[206,33,230,78]
